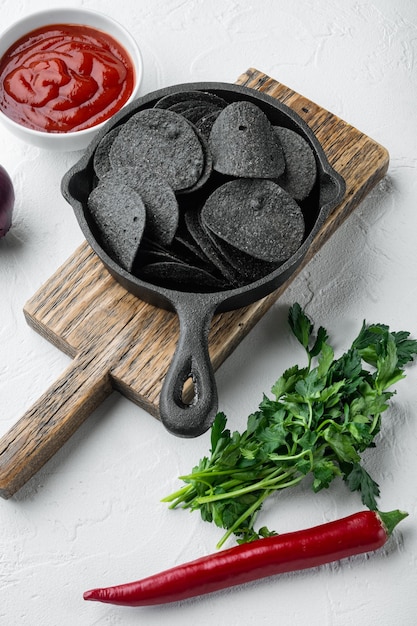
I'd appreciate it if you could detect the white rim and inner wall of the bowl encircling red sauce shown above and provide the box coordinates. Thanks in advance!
[0,6,143,143]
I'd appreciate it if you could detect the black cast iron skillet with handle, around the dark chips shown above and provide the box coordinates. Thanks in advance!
[62,83,345,437]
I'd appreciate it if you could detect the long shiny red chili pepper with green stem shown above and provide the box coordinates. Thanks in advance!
[84,511,407,606]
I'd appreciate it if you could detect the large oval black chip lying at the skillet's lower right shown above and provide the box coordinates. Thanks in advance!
[201,178,304,263]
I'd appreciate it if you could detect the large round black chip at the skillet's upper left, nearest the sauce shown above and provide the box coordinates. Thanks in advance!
[109,108,205,190]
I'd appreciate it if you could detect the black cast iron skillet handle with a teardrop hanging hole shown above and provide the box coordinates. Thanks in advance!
[159,294,217,437]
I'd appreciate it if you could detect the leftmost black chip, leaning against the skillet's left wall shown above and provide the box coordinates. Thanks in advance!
[88,181,146,271]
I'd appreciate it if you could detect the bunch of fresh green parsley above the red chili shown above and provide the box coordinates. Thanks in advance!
[163,303,417,547]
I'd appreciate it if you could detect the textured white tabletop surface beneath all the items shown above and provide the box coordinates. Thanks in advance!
[0,0,417,626]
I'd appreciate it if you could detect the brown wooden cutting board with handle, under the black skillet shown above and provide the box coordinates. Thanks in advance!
[0,69,389,498]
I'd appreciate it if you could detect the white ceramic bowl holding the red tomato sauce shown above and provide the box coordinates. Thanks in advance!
[0,8,143,151]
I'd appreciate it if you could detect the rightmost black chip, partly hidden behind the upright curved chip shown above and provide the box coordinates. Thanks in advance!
[274,126,317,200]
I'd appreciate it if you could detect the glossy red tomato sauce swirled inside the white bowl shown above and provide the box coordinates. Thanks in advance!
[0,24,135,133]
